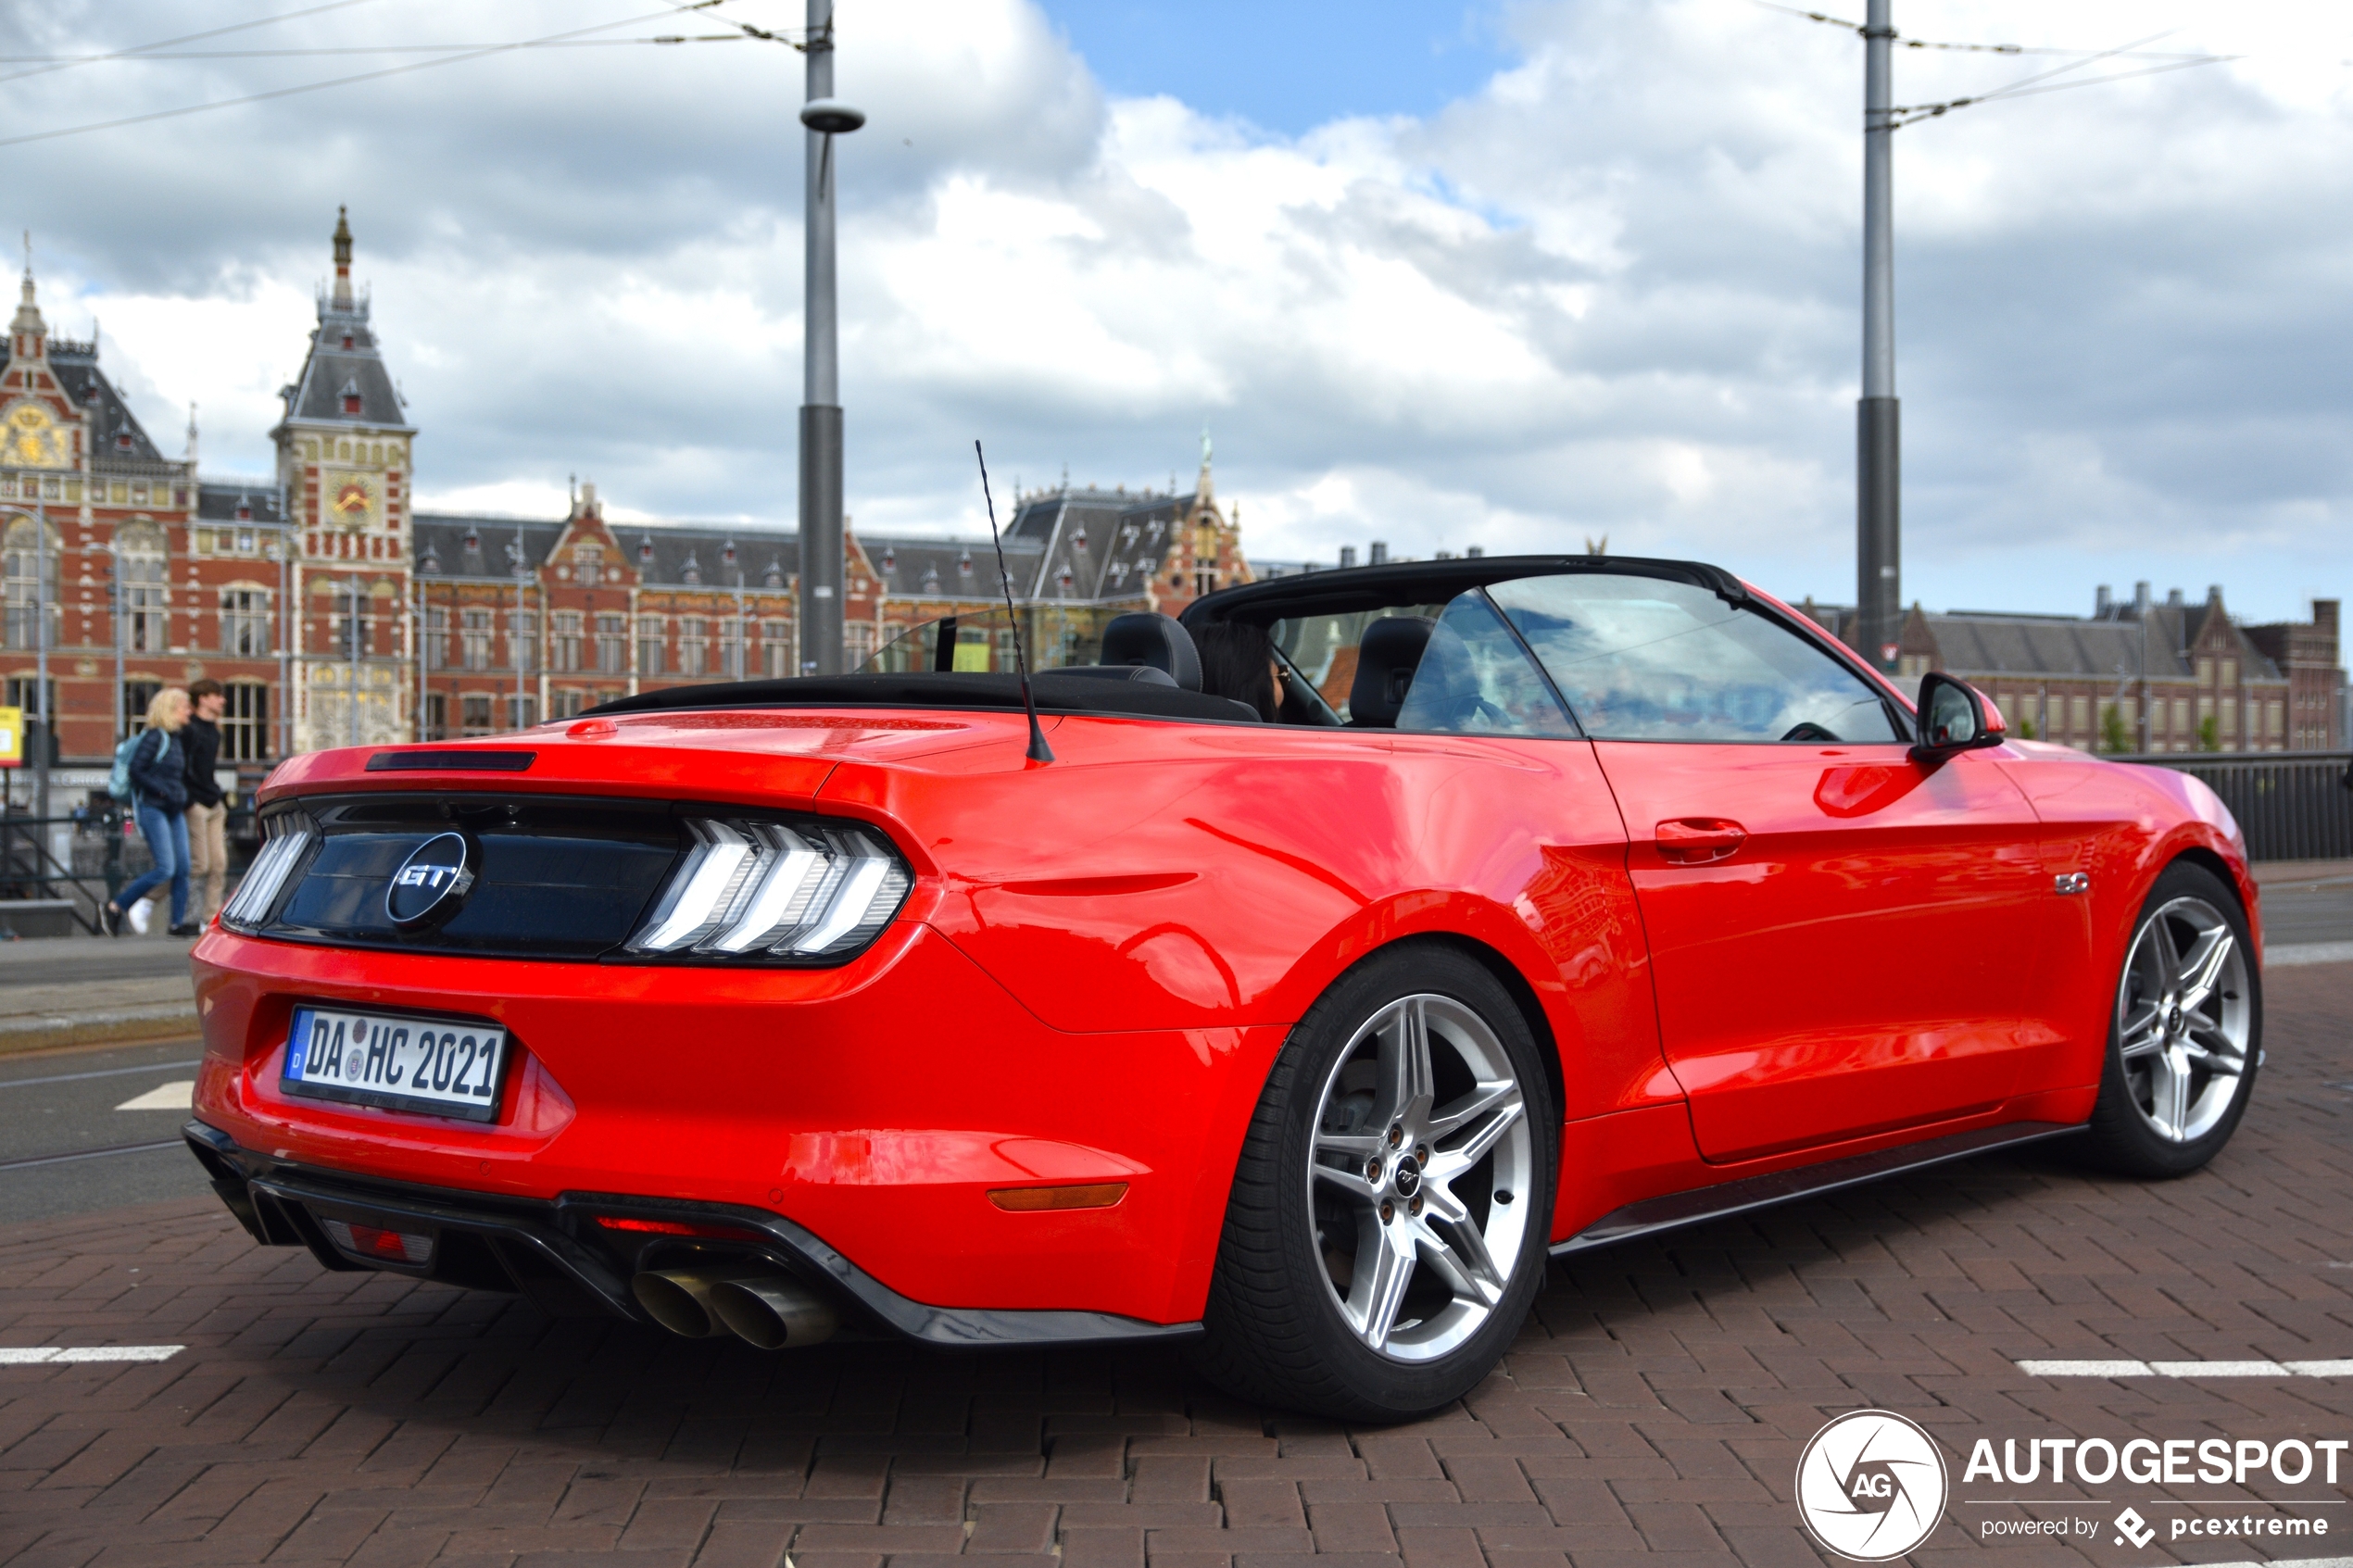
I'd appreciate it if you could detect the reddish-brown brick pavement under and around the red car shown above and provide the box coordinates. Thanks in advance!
[0,966,2353,1568]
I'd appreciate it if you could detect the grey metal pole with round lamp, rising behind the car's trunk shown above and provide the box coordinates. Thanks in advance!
[800,0,866,674]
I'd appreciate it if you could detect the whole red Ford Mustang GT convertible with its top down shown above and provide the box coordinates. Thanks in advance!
[186,558,2263,1420]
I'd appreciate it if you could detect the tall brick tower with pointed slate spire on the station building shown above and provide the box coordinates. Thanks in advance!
[271,209,417,752]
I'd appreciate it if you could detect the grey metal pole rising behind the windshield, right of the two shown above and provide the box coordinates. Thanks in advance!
[1855,0,1904,670]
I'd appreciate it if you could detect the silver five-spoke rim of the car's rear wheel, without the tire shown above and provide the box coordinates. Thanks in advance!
[1306,995,1541,1361]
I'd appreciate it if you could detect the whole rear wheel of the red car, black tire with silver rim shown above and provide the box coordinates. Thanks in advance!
[1195,943,1560,1423]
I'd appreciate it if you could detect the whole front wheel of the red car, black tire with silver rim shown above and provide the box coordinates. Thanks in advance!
[2078,860,2263,1178]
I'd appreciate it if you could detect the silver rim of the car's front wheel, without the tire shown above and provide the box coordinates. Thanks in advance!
[2115,898,2252,1143]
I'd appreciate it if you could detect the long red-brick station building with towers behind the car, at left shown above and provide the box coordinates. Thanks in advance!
[0,214,1250,773]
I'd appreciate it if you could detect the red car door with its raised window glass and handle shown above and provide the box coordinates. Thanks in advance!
[1491,573,2049,1161]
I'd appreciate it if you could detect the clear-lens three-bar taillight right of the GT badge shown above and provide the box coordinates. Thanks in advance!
[628,816,915,961]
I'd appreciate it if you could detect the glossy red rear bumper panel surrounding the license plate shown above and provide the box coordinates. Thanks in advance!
[193,922,1282,1323]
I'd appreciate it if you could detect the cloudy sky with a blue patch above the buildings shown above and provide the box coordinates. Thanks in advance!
[0,0,2353,619]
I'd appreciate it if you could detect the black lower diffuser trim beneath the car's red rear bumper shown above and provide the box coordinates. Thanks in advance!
[182,1122,1200,1349]
